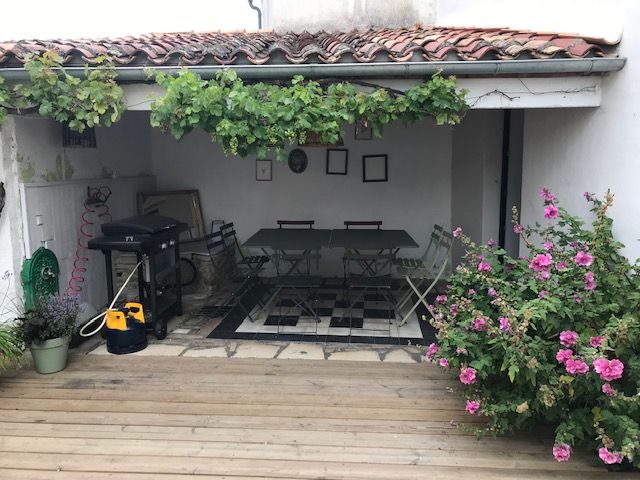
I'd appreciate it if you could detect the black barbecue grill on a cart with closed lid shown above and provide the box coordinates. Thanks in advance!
[89,215,187,339]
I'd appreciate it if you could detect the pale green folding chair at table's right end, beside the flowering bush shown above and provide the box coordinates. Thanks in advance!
[394,225,453,325]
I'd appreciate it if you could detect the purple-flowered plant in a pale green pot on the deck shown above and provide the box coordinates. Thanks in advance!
[17,293,80,373]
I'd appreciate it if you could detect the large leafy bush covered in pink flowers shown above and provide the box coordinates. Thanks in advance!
[428,189,640,468]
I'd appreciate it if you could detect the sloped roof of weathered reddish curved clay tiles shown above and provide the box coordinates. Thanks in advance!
[0,26,615,66]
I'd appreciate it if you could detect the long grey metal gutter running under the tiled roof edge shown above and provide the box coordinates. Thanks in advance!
[0,57,627,82]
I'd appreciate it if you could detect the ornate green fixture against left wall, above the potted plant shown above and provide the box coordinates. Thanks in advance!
[20,247,60,311]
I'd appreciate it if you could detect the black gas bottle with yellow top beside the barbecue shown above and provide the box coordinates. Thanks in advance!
[106,302,147,354]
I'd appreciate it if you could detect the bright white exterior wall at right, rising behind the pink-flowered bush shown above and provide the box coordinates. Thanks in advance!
[522,1,640,258]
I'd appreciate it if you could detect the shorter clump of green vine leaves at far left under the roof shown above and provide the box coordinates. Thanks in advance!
[0,50,125,132]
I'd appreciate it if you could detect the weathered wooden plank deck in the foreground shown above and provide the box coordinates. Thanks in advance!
[0,355,607,480]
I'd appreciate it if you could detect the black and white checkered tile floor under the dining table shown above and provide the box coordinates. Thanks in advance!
[205,286,431,344]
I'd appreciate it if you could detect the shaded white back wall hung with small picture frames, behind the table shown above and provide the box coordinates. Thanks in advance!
[151,118,452,274]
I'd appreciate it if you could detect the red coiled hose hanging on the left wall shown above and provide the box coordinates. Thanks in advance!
[67,186,112,294]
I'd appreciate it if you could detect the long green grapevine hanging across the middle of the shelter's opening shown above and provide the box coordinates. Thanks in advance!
[151,69,468,159]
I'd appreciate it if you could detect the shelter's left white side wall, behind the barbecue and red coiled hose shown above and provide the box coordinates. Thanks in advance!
[0,112,155,316]
